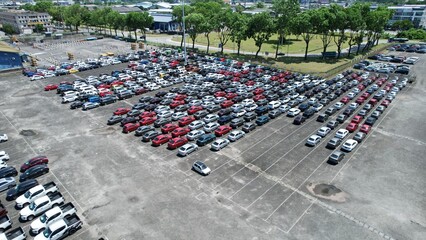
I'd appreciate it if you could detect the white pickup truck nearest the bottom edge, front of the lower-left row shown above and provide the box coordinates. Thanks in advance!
[34,214,83,240]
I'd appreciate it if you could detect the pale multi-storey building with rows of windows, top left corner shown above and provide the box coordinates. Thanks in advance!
[0,10,52,33]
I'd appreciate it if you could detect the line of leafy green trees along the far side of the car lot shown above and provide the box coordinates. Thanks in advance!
[20,0,392,59]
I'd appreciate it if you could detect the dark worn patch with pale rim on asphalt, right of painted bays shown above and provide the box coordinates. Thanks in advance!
[306,183,348,202]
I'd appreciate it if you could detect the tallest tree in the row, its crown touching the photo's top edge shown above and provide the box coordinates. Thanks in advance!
[272,0,300,58]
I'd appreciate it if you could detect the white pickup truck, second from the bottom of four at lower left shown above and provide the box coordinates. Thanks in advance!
[30,202,77,235]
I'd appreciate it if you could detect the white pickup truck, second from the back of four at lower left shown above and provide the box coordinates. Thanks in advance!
[19,192,65,221]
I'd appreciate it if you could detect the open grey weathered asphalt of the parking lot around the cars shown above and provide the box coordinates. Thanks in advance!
[0,41,426,239]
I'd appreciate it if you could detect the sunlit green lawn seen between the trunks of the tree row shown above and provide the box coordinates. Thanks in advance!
[173,33,348,54]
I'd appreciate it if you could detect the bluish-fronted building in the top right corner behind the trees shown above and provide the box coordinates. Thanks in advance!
[388,5,426,28]
